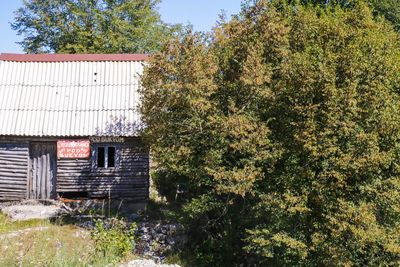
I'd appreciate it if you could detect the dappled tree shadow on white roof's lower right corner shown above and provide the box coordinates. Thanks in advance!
[95,115,143,136]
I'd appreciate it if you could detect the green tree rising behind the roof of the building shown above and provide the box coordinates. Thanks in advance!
[11,0,180,53]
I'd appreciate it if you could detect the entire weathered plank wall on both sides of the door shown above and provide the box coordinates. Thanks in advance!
[0,136,149,202]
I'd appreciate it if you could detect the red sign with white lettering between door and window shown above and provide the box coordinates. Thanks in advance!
[57,139,90,159]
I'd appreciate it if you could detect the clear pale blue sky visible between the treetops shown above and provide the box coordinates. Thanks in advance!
[0,0,242,53]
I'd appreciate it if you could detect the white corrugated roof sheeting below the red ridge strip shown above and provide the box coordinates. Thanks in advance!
[0,55,143,136]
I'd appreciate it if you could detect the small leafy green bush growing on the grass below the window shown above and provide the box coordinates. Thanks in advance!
[91,218,136,263]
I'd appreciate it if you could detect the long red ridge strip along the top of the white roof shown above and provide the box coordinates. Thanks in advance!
[0,53,149,62]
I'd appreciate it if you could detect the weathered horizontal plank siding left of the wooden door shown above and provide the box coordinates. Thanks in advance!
[0,142,29,200]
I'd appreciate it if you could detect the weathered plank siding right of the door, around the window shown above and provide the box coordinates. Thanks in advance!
[57,140,149,201]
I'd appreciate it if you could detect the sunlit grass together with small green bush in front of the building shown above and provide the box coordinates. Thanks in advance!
[0,213,135,266]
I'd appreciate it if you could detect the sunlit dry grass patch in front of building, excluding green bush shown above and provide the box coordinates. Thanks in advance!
[0,213,133,266]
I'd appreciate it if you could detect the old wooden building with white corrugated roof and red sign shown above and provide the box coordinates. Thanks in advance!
[0,54,149,206]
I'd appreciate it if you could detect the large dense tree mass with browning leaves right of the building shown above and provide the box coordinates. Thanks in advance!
[141,0,400,266]
